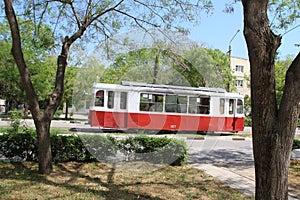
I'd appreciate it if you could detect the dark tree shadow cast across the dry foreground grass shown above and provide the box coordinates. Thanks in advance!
[0,163,160,200]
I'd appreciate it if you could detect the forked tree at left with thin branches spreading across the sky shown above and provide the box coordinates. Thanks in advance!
[4,0,211,174]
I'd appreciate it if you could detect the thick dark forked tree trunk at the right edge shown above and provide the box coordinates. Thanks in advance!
[242,0,300,199]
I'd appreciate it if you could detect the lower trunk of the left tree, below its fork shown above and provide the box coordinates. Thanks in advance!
[35,119,52,174]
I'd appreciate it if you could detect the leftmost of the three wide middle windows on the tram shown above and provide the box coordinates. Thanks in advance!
[140,93,164,112]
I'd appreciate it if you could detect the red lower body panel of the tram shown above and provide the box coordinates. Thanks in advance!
[90,111,244,132]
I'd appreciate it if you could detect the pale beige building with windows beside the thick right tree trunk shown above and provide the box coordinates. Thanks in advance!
[230,57,250,96]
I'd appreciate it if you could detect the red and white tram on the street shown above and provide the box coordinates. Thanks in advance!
[90,82,244,132]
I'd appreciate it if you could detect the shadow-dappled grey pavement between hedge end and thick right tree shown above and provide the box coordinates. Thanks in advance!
[188,136,300,200]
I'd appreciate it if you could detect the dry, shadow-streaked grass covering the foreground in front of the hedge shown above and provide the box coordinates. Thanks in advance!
[0,162,251,200]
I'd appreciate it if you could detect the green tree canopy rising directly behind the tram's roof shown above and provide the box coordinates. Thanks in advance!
[100,44,229,88]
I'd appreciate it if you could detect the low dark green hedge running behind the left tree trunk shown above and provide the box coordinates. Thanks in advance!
[0,129,187,165]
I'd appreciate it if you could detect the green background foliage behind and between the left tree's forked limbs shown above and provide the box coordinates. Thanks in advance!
[0,20,55,114]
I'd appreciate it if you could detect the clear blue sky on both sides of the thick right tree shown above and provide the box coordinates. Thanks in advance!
[190,0,300,59]
